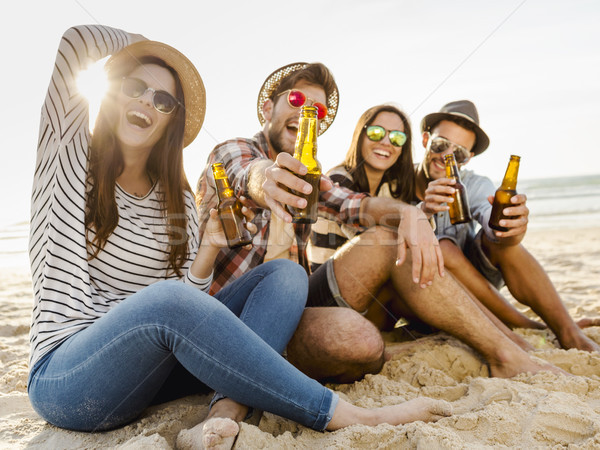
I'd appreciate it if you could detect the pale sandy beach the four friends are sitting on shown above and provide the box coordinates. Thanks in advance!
[0,227,600,449]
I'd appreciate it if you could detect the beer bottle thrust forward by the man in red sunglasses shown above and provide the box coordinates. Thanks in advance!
[287,105,321,223]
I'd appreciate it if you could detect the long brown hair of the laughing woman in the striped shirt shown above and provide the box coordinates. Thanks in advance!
[85,57,192,276]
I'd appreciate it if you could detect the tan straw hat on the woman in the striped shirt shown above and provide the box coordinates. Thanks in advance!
[104,40,206,147]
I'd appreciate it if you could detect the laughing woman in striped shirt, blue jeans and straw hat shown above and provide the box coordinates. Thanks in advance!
[28,26,447,445]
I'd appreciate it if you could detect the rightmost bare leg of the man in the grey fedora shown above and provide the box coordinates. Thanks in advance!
[482,237,600,351]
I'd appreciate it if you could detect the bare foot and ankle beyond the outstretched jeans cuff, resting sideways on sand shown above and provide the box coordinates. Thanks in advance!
[327,397,452,431]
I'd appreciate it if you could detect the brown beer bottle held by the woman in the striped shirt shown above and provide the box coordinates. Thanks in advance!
[212,163,252,248]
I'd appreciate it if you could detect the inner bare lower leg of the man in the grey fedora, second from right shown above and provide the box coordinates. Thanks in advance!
[440,239,546,330]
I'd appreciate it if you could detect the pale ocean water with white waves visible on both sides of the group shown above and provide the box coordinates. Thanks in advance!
[0,175,600,268]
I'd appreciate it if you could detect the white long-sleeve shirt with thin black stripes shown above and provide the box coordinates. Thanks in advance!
[29,25,211,368]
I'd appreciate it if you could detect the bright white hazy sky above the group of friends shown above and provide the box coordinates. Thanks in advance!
[0,0,600,226]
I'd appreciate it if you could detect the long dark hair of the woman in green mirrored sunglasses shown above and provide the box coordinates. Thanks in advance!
[344,104,415,203]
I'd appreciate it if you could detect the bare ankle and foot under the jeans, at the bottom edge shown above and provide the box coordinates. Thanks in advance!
[177,398,248,450]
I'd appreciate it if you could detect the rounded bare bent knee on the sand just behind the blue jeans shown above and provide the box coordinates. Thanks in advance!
[287,307,384,383]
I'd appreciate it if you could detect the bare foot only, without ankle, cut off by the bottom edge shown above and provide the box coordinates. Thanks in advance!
[177,417,240,450]
